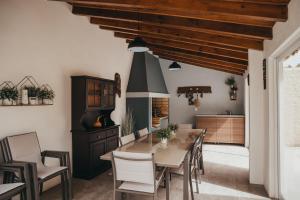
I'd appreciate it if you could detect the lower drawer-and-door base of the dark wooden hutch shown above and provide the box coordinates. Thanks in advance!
[72,126,119,179]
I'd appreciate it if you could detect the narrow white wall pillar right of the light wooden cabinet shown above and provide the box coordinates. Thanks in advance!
[248,50,266,184]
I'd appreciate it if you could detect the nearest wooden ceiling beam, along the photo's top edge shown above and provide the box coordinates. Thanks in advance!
[65,0,287,25]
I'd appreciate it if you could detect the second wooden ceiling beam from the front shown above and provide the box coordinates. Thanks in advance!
[72,6,272,39]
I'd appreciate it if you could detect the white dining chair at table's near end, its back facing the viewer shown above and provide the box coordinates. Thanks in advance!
[112,151,165,200]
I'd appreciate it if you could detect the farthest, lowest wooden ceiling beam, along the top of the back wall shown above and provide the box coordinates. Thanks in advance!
[154,52,244,75]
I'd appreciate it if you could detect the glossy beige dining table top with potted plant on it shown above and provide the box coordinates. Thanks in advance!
[100,129,204,168]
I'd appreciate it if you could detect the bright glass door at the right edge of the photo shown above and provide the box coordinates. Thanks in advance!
[278,46,300,200]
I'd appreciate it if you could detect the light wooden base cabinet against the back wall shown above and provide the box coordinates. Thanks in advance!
[196,115,245,145]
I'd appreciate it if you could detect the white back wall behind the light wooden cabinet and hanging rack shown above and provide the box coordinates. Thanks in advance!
[160,59,244,126]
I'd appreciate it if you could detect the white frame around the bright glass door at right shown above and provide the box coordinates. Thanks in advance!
[268,28,300,199]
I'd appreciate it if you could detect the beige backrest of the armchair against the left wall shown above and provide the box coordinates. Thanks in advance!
[5,132,43,168]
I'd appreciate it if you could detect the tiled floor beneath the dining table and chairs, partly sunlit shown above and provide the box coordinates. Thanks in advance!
[42,145,268,200]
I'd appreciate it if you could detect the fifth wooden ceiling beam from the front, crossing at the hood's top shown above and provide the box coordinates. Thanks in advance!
[115,33,248,61]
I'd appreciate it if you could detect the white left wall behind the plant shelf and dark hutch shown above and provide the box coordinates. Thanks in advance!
[0,0,132,166]
